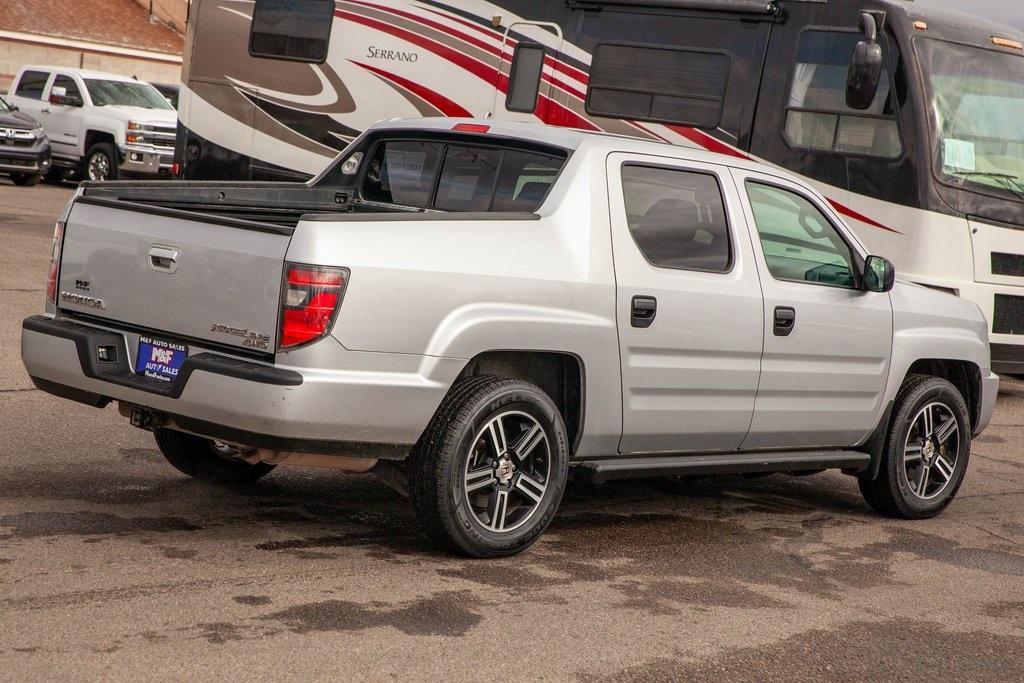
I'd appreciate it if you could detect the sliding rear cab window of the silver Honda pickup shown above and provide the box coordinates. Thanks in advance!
[361,140,565,212]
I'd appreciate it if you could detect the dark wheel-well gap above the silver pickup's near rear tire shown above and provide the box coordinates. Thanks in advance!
[456,349,587,456]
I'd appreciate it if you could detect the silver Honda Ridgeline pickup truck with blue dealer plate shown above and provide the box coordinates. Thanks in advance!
[22,119,998,557]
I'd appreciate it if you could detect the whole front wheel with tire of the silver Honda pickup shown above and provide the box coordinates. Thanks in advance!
[858,375,971,519]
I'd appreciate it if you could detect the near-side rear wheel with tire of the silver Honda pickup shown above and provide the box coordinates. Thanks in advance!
[409,376,568,557]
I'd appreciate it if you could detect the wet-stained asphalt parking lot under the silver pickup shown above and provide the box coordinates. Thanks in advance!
[6,180,1024,681]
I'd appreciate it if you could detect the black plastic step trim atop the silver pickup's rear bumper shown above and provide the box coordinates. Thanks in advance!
[22,315,302,398]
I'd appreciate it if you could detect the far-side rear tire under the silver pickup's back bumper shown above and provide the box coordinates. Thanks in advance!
[154,429,274,484]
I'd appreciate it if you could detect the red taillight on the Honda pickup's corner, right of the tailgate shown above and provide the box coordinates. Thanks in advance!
[278,263,348,350]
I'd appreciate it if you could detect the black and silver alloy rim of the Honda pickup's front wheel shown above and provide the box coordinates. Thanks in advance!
[902,402,963,501]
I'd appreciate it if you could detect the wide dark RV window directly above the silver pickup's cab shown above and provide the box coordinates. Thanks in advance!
[587,43,731,128]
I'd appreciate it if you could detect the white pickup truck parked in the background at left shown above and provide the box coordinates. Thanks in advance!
[7,66,177,180]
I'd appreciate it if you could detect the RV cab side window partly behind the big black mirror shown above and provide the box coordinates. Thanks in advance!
[785,31,903,159]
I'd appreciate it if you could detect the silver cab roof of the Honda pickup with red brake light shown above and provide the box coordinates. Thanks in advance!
[368,118,782,178]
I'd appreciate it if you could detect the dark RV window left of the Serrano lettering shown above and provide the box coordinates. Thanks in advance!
[249,0,334,63]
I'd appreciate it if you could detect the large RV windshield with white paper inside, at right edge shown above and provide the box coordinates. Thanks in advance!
[918,40,1024,201]
